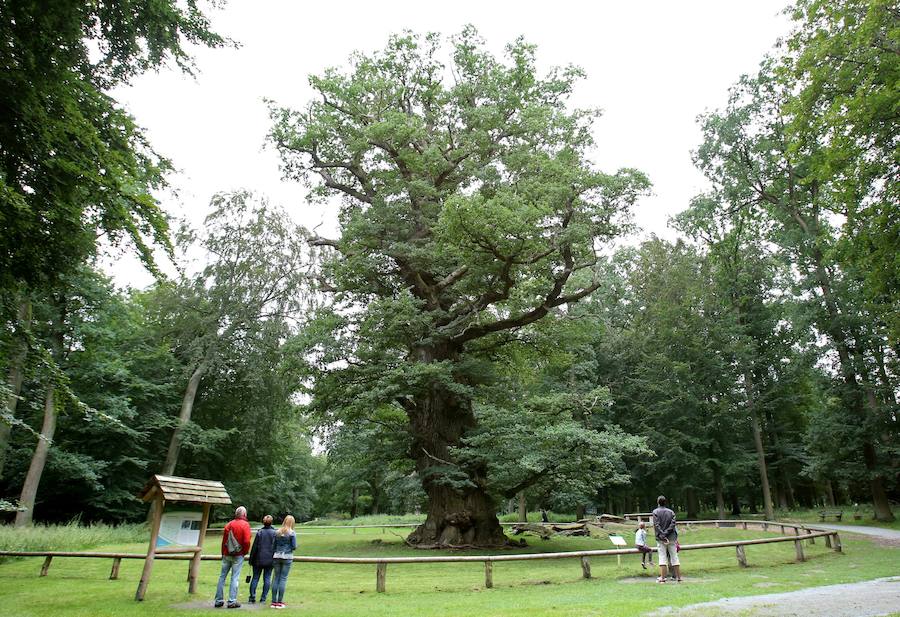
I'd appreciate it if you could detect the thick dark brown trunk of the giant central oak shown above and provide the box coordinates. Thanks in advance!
[407,348,507,548]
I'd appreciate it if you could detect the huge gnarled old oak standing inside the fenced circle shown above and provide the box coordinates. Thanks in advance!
[271,28,648,545]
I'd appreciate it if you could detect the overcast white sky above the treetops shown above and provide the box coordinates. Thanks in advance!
[110,0,790,287]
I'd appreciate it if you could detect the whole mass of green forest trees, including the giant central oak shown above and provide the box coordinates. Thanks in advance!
[0,0,900,528]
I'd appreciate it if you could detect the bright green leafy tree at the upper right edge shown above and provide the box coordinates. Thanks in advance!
[781,0,900,344]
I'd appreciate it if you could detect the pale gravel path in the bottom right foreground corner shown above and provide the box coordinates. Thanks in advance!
[650,576,900,617]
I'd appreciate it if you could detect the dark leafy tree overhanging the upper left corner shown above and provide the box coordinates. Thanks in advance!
[0,0,226,482]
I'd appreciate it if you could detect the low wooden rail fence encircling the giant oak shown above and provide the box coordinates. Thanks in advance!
[0,520,842,592]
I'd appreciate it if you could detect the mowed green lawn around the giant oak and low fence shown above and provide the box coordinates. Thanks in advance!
[0,527,900,617]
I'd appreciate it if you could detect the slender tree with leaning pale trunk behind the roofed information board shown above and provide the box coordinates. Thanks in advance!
[156,192,308,475]
